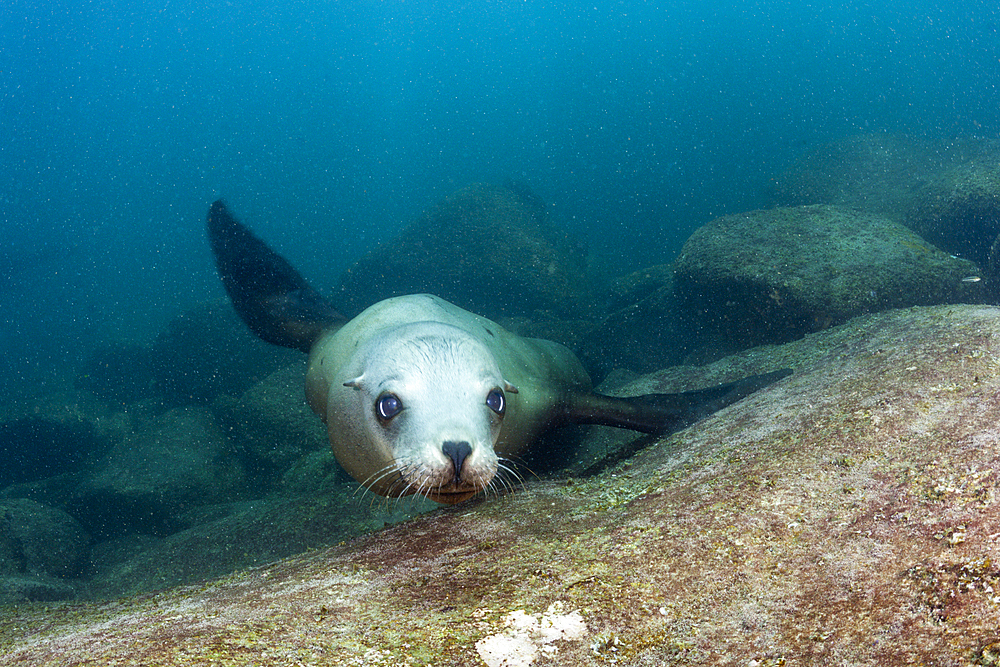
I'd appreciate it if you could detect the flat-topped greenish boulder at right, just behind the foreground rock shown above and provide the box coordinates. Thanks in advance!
[672,206,987,351]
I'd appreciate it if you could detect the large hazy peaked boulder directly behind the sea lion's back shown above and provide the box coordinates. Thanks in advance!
[338,183,590,319]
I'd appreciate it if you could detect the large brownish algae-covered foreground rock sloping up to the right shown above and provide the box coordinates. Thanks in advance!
[0,306,1000,666]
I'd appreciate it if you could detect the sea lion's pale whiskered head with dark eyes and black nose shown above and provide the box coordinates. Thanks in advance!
[328,322,517,503]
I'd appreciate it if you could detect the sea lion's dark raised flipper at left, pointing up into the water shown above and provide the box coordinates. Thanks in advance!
[207,199,346,352]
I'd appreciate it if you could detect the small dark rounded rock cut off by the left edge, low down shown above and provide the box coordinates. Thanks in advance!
[0,498,90,578]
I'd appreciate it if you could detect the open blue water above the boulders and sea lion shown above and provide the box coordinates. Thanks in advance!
[0,0,1000,390]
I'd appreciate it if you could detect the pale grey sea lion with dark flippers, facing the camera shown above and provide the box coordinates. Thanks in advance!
[207,201,790,504]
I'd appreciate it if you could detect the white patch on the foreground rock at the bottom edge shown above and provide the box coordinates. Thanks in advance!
[476,602,587,667]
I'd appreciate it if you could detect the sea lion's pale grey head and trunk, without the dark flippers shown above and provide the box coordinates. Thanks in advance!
[306,294,590,502]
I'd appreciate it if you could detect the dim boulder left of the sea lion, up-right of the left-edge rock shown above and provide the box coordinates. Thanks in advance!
[69,407,248,537]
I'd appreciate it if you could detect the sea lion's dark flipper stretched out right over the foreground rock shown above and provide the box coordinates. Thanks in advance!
[563,368,792,435]
